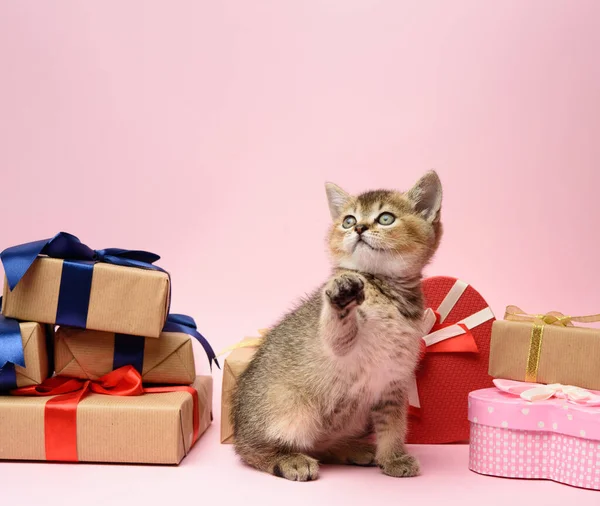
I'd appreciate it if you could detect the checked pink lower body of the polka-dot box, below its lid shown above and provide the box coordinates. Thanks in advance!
[469,423,600,490]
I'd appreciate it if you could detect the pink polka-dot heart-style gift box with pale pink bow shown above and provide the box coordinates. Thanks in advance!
[469,380,600,490]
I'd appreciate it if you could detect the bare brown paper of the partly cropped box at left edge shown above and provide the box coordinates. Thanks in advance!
[4,322,49,388]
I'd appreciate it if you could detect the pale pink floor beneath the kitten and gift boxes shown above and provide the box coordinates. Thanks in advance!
[0,394,599,506]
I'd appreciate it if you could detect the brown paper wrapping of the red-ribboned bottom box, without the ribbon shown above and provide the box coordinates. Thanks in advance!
[0,376,213,464]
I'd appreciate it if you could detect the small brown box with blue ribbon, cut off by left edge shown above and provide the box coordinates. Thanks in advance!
[0,316,52,392]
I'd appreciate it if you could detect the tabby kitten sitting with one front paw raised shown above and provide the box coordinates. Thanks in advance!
[231,171,442,481]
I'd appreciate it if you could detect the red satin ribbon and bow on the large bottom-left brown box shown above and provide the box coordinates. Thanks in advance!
[11,365,200,462]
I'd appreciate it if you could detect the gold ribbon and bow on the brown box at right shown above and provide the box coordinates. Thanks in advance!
[504,306,600,383]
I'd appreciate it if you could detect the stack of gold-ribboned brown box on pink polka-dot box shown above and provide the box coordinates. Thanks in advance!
[469,306,600,490]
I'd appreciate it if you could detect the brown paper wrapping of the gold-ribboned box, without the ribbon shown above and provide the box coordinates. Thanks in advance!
[489,320,600,390]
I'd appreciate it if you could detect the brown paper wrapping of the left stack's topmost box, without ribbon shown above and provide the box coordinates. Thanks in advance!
[2,257,170,338]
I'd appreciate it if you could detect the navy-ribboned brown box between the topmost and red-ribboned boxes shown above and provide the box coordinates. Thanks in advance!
[54,315,218,385]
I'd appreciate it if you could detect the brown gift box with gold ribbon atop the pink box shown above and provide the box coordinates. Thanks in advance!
[489,306,600,390]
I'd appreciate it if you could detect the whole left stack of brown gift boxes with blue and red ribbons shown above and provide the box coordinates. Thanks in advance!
[0,233,215,464]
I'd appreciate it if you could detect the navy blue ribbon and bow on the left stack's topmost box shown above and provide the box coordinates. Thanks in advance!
[0,232,166,328]
